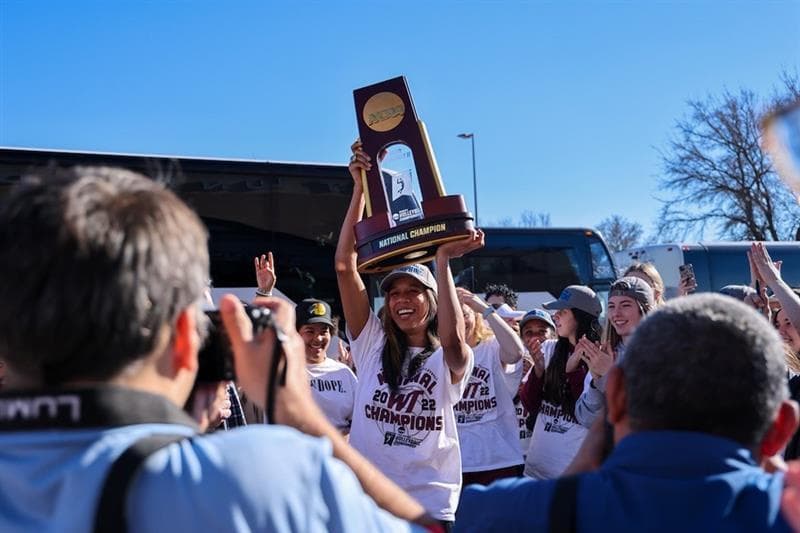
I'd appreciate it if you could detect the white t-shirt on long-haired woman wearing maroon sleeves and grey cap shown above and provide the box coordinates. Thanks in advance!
[525,340,589,479]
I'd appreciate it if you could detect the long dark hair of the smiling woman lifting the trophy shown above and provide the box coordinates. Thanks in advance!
[378,288,439,392]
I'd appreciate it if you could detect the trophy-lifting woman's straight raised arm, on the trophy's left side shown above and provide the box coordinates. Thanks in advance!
[335,141,372,338]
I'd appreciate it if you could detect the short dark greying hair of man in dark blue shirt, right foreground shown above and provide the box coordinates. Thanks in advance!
[620,293,788,449]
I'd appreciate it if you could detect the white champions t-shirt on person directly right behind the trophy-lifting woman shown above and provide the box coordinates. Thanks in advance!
[453,337,523,472]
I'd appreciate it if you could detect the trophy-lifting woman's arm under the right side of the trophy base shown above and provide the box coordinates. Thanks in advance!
[436,230,483,383]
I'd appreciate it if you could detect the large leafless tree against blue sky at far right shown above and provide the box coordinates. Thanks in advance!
[658,74,800,240]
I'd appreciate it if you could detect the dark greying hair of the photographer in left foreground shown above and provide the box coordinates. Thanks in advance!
[0,167,208,385]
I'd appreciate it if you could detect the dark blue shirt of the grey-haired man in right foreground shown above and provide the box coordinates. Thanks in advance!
[455,431,790,532]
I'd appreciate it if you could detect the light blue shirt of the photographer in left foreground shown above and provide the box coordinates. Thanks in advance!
[0,408,412,532]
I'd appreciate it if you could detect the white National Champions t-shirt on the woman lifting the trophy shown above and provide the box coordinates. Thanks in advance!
[348,313,473,521]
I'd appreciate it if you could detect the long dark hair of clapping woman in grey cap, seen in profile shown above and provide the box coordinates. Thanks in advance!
[542,307,600,416]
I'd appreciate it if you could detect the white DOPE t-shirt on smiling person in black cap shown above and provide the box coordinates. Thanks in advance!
[306,357,358,433]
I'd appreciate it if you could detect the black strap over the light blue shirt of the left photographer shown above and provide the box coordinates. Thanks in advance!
[94,435,190,533]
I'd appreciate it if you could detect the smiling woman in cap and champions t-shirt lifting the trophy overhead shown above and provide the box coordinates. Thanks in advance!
[336,141,483,524]
